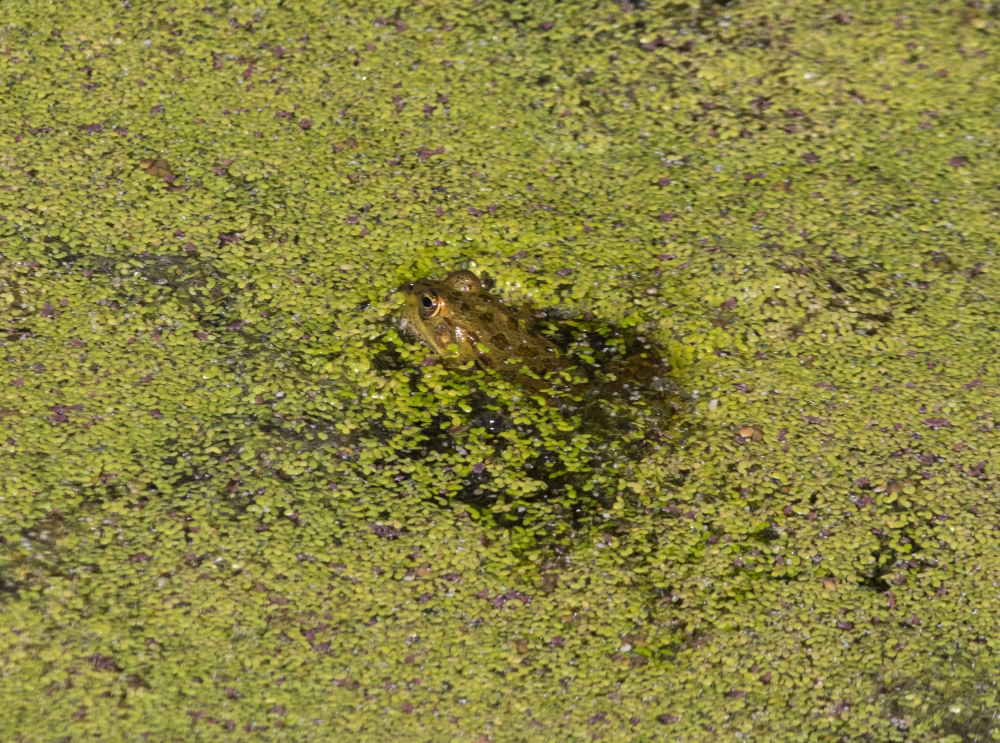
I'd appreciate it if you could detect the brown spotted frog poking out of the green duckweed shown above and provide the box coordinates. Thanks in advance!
[401,269,565,375]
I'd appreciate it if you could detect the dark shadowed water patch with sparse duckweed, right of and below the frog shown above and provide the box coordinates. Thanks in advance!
[394,313,689,535]
